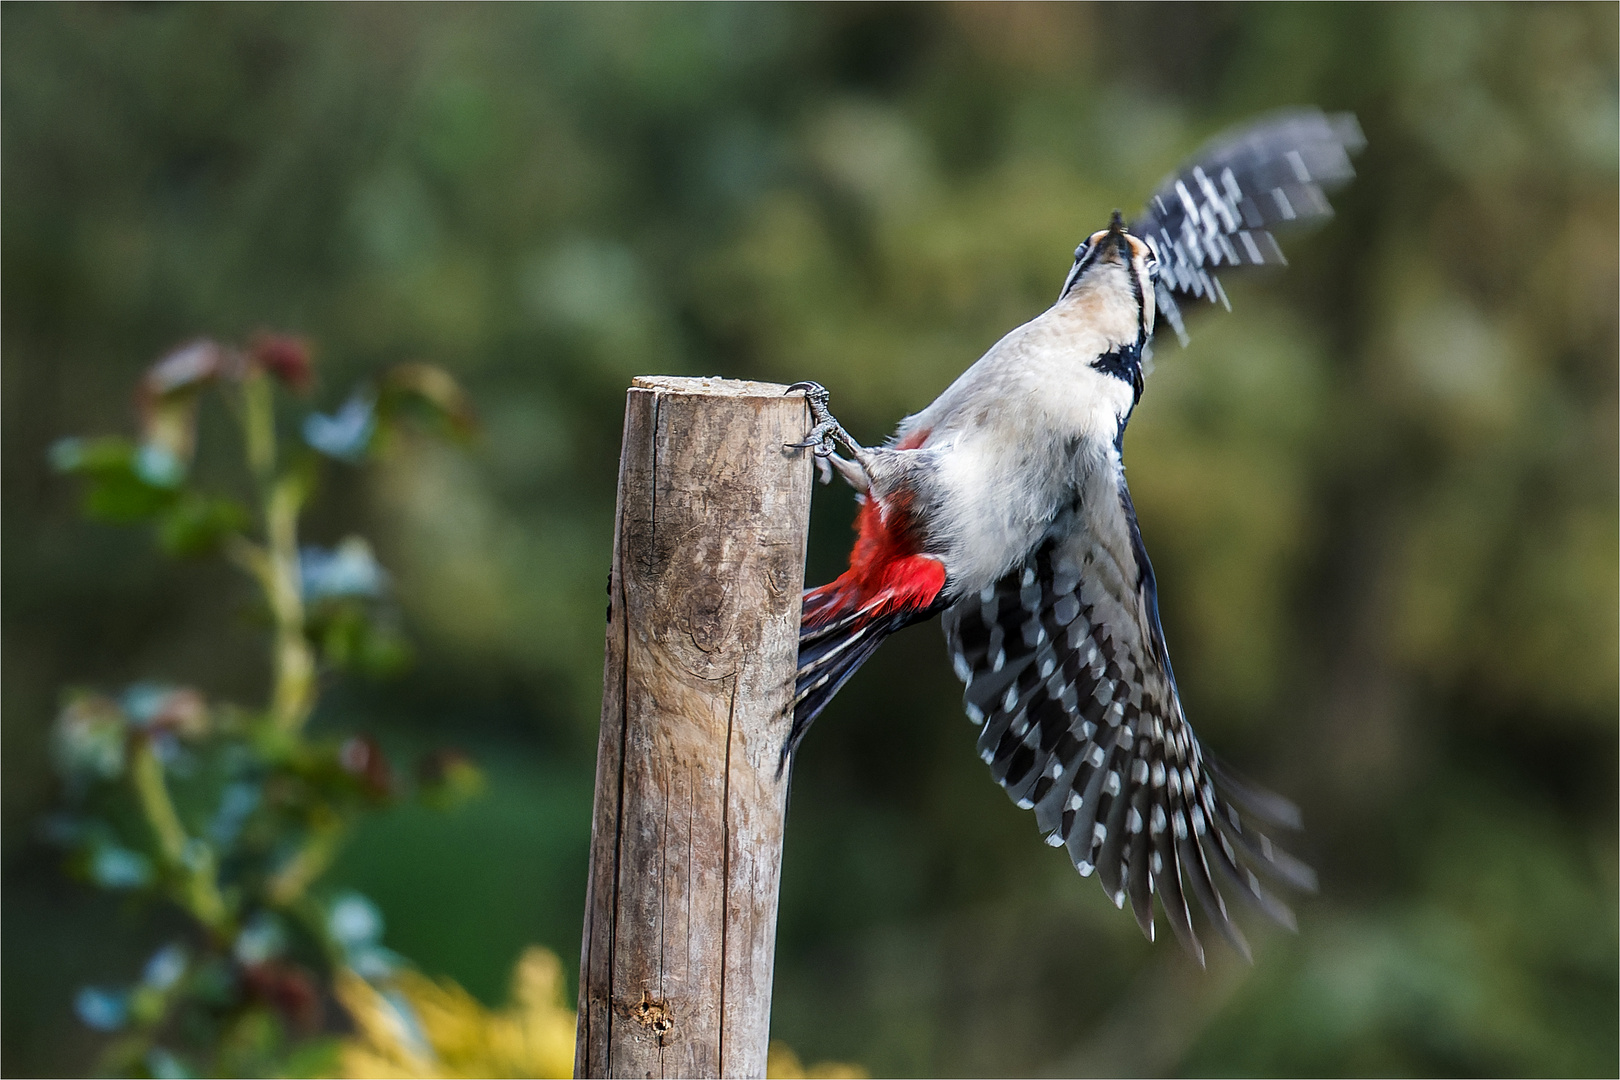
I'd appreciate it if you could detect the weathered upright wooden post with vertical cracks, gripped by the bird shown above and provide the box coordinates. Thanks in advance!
[573,377,812,1077]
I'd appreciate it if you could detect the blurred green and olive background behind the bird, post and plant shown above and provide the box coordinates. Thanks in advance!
[0,3,1620,1075]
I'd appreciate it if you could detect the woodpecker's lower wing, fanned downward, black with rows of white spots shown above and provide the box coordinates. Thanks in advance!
[944,478,1315,963]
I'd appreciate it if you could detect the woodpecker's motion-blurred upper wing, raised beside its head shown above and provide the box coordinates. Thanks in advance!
[1131,108,1364,342]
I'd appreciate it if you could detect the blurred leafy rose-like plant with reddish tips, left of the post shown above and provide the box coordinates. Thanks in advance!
[42,334,482,1077]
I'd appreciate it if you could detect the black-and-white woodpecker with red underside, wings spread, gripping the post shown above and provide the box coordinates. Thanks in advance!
[782,110,1362,963]
